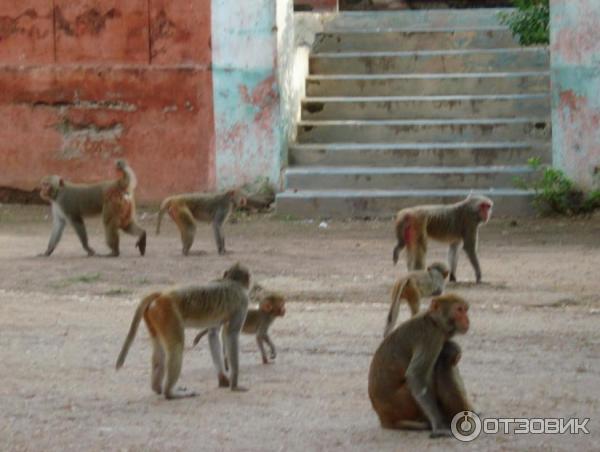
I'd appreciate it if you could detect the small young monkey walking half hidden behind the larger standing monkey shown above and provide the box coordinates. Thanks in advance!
[194,284,285,368]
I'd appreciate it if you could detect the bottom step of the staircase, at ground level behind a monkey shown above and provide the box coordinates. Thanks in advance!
[276,189,534,218]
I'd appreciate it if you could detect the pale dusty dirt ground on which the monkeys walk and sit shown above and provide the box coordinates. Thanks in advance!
[0,205,600,451]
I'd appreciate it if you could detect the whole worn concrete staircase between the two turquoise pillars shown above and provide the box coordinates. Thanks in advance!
[277,9,551,217]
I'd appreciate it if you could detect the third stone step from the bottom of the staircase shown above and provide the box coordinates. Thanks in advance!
[289,142,551,167]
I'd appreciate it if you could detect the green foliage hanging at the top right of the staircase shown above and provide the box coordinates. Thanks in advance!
[499,0,550,46]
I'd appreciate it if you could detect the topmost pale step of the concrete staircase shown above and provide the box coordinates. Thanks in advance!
[294,8,512,32]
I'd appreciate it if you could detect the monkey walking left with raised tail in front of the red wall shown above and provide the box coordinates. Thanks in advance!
[40,159,146,256]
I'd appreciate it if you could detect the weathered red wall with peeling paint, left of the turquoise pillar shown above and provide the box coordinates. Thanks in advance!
[0,0,215,201]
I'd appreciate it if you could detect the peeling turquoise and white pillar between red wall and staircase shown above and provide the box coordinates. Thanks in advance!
[211,0,293,188]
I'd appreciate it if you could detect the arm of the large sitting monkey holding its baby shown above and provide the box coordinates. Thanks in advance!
[405,344,445,435]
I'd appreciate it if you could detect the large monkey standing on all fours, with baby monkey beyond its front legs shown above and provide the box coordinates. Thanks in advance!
[116,263,250,399]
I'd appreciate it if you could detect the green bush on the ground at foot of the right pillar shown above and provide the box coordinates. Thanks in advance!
[515,157,600,215]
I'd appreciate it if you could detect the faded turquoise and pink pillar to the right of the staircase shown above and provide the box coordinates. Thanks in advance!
[550,0,600,190]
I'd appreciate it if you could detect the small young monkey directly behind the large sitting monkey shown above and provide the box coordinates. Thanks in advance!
[383,262,450,337]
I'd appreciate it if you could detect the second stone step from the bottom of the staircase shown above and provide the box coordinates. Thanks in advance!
[285,166,535,190]
